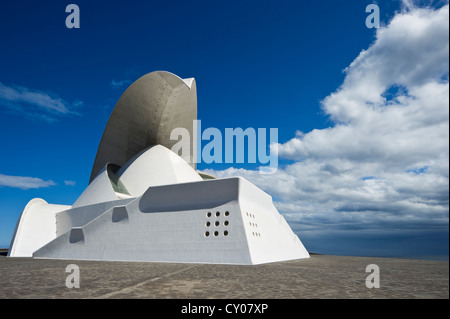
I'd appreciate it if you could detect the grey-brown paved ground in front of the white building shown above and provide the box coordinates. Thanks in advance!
[0,255,449,299]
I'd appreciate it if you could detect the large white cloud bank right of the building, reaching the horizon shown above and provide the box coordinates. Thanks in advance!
[207,2,449,238]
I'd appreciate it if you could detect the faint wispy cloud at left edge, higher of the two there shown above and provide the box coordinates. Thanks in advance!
[0,82,83,122]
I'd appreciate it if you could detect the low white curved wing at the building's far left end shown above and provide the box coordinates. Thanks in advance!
[8,198,71,257]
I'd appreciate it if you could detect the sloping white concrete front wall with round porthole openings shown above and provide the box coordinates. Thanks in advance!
[34,178,309,264]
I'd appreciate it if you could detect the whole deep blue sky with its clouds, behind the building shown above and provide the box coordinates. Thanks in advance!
[0,0,449,260]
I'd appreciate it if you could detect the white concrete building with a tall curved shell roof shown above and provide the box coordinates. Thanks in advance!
[9,71,309,264]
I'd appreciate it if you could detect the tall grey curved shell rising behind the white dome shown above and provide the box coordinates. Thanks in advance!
[89,71,197,182]
